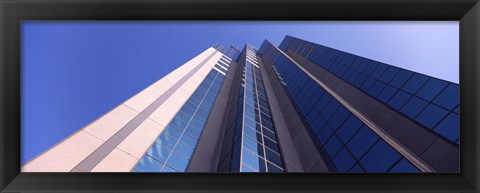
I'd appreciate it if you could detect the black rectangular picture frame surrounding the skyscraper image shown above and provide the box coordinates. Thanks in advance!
[0,0,480,192]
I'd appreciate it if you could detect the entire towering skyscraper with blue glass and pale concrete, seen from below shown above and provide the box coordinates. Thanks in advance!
[22,36,459,172]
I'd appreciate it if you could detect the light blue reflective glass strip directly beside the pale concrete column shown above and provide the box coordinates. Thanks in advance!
[132,51,231,172]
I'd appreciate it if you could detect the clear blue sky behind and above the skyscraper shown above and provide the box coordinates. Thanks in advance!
[21,21,459,164]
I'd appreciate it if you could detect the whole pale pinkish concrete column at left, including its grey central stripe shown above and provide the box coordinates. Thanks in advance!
[22,48,221,172]
